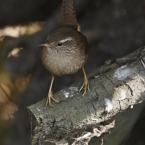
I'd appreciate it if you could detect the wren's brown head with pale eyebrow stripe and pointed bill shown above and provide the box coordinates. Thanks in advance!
[40,27,86,52]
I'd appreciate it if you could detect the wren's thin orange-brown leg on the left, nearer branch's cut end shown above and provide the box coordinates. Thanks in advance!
[46,75,58,106]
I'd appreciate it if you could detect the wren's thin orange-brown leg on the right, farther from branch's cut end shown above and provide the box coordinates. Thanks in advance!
[79,67,90,96]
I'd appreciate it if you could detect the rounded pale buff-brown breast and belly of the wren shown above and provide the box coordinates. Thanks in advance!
[41,48,87,76]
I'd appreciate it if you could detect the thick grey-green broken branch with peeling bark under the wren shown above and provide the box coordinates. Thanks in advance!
[28,47,145,145]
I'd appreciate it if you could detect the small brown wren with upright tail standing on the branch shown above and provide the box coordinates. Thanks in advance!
[40,0,89,105]
